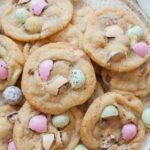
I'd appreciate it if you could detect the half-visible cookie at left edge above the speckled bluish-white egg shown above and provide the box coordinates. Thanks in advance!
[0,35,25,91]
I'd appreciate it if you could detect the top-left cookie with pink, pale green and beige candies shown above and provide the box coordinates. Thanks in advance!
[2,0,73,42]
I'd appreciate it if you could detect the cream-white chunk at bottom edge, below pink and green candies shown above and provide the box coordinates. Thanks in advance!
[42,134,55,150]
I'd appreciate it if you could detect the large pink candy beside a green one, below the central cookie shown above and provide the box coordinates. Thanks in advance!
[28,115,47,133]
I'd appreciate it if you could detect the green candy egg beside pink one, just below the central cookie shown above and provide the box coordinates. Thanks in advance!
[52,114,70,128]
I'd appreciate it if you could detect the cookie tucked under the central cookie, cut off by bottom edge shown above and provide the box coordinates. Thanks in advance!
[13,103,82,150]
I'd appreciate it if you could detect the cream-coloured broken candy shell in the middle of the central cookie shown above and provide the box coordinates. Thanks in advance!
[46,75,68,95]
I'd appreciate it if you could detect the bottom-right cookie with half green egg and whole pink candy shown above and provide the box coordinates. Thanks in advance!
[80,92,145,150]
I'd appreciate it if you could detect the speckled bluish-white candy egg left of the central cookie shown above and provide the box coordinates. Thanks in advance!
[2,86,22,105]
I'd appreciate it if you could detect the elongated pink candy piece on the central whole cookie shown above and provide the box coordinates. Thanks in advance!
[39,60,53,81]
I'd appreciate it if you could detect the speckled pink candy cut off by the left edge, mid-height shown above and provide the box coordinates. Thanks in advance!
[0,59,8,80]
